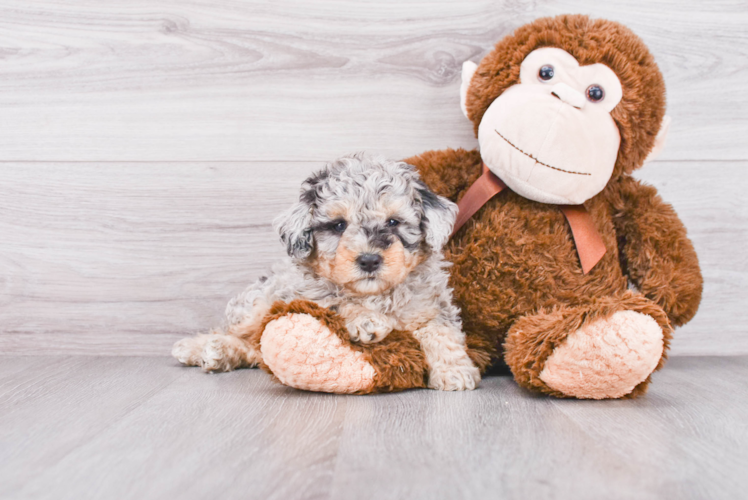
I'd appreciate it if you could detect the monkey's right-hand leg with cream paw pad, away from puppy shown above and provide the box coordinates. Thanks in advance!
[504,292,672,399]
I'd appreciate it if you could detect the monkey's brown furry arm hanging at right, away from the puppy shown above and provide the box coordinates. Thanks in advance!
[611,177,703,326]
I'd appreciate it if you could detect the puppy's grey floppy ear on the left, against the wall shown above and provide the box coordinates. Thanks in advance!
[273,170,328,259]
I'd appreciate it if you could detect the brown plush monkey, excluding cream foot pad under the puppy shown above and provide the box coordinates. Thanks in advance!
[258,15,702,399]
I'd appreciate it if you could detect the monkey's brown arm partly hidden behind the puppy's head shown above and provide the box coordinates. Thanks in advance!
[403,148,481,201]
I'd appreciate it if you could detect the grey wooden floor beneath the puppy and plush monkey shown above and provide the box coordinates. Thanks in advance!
[0,356,748,500]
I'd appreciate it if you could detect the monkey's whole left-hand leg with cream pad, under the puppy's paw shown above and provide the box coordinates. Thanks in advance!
[259,300,428,394]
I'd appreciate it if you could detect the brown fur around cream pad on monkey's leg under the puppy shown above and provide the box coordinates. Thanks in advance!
[258,300,429,394]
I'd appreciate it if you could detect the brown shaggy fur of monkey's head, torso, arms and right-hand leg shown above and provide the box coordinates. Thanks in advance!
[406,16,702,397]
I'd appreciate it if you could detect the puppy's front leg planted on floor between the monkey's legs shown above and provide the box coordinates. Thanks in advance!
[413,322,480,391]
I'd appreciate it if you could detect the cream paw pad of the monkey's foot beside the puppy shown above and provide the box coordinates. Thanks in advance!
[260,314,376,393]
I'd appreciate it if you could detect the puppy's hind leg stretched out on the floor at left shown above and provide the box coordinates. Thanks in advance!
[171,300,270,372]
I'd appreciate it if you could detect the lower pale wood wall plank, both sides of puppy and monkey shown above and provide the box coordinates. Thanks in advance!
[0,162,748,356]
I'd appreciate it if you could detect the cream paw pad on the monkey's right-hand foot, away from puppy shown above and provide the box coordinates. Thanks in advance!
[540,311,663,399]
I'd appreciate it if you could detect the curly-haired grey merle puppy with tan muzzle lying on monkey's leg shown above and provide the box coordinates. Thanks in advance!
[172,154,480,390]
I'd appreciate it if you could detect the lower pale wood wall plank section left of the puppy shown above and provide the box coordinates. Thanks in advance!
[0,163,321,355]
